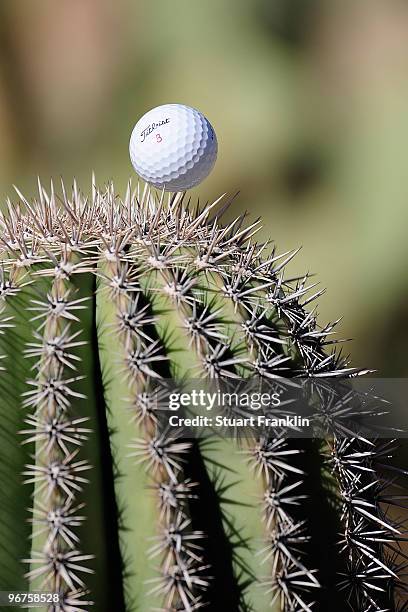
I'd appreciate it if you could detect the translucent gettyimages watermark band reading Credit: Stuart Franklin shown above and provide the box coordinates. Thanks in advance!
[149,377,408,439]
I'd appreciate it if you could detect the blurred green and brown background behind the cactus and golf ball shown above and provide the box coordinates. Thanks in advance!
[0,0,408,376]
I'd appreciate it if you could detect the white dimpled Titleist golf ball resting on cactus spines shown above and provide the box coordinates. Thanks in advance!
[129,104,218,191]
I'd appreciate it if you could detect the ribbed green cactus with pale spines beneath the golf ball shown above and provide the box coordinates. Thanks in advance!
[0,181,404,612]
